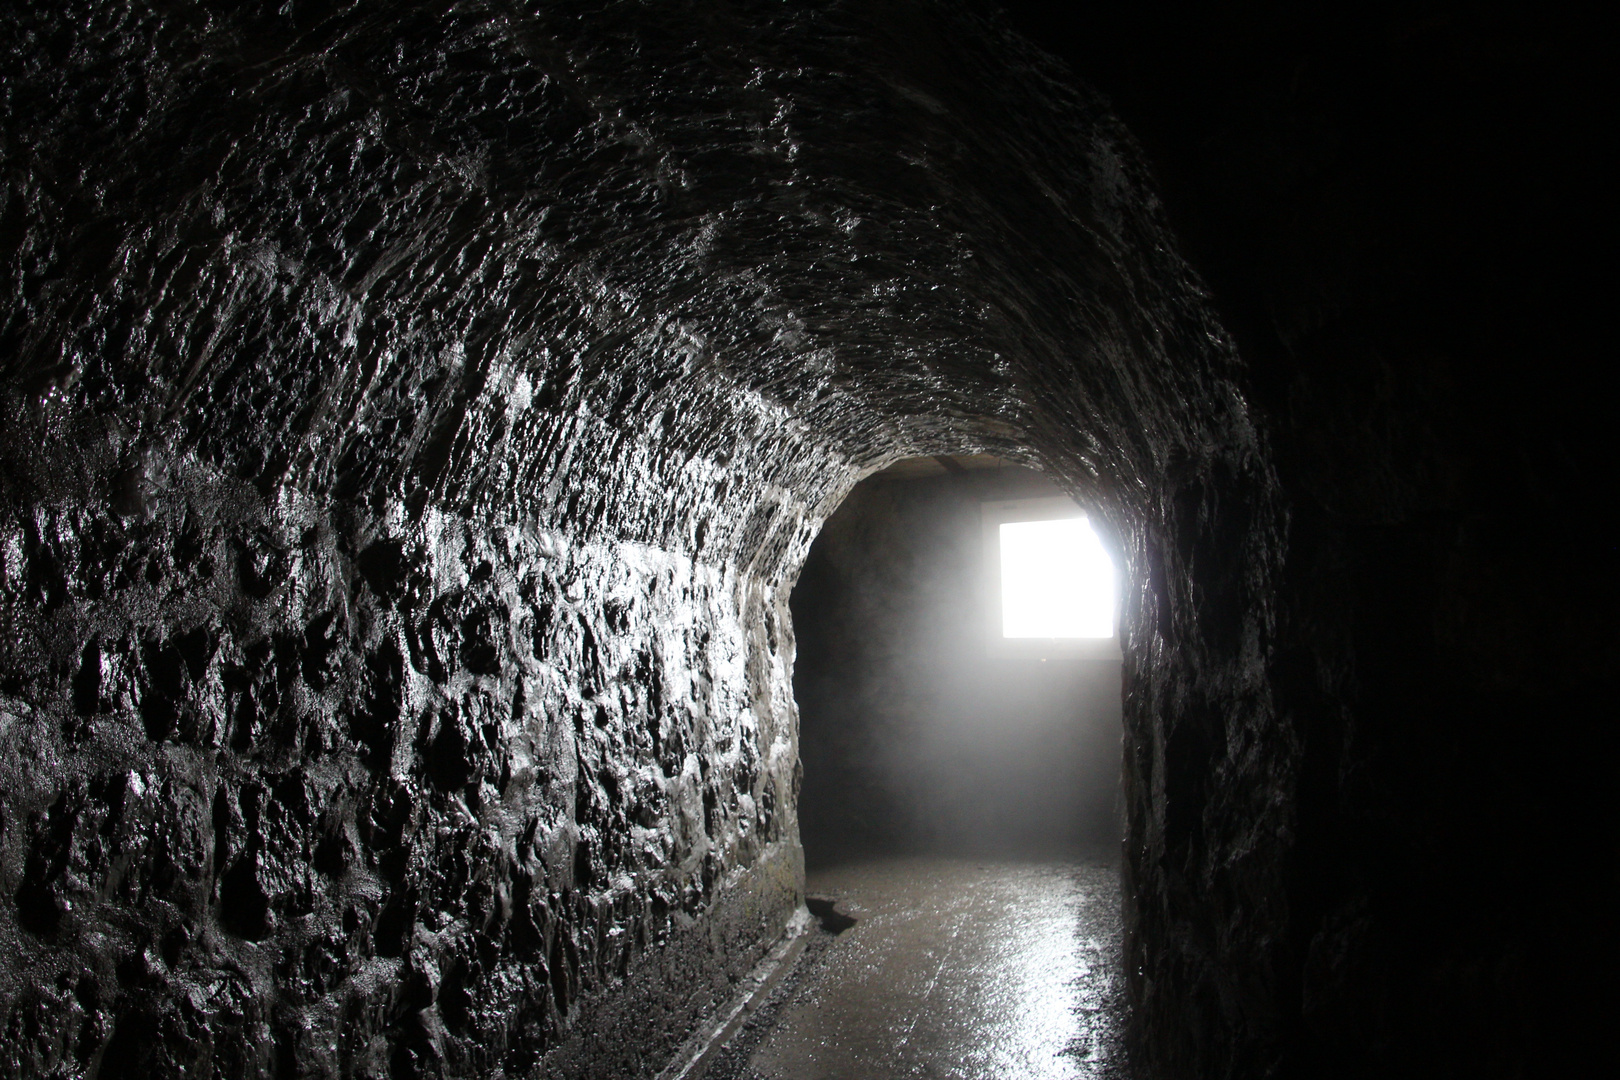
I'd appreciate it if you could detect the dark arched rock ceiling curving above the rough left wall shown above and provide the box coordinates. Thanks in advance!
[0,5,1252,573]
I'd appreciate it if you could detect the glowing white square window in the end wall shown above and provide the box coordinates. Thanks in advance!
[1001,518,1115,638]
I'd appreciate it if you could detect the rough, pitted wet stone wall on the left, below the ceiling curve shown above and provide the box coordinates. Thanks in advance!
[0,459,799,1077]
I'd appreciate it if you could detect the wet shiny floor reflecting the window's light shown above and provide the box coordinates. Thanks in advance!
[706,857,1126,1080]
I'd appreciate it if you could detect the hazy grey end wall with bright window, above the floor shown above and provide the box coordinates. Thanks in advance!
[792,457,1121,868]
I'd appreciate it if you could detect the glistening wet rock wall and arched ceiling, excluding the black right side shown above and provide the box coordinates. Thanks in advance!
[0,0,1276,1077]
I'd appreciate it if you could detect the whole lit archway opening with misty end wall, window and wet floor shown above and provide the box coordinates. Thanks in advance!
[714,455,1126,1080]
